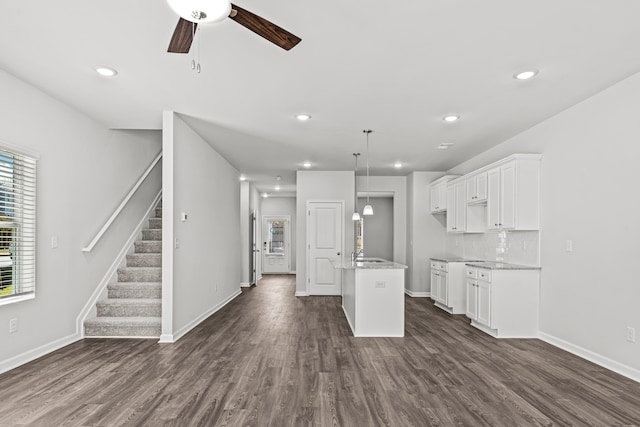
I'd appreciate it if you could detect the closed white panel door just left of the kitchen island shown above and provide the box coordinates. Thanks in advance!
[307,202,344,295]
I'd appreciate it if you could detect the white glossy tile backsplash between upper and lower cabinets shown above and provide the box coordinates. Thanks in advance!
[447,230,540,266]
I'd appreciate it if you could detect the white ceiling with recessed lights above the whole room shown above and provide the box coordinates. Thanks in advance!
[0,0,640,195]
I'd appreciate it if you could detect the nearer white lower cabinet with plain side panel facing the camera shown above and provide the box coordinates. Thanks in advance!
[465,266,540,338]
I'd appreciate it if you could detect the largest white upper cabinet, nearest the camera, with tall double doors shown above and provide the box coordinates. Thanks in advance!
[487,155,540,230]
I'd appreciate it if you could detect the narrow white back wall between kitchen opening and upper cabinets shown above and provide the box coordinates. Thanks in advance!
[405,172,446,296]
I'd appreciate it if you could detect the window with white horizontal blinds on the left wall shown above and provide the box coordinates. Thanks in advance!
[0,149,36,304]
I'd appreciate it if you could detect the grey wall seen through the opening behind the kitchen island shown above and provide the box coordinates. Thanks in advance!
[358,197,393,260]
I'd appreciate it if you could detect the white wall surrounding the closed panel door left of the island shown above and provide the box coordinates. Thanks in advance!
[296,171,355,293]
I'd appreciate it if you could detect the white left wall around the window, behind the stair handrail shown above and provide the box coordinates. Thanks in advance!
[0,70,161,372]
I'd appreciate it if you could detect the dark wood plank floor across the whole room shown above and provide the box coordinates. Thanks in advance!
[0,276,640,427]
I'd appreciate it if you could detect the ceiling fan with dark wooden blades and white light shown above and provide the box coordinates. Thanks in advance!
[167,0,301,53]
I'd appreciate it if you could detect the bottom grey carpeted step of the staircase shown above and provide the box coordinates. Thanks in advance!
[84,317,162,338]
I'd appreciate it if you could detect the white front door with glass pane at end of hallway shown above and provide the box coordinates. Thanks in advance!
[262,215,291,274]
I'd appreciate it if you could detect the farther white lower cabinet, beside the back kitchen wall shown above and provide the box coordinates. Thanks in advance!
[430,259,466,314]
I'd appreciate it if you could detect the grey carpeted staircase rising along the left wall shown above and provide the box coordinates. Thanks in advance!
[84,202,162,338]
